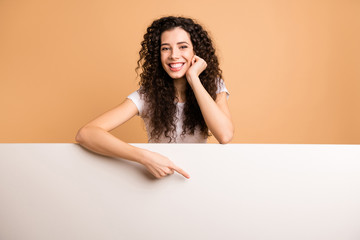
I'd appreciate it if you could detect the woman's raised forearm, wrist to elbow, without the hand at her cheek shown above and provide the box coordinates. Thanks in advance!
[189,77,234,143]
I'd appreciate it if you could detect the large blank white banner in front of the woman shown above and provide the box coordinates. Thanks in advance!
[0,144,360,240]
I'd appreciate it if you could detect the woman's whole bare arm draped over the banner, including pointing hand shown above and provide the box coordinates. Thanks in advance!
[76,99,190,178]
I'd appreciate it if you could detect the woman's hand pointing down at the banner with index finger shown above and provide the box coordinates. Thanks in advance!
[141,151,190,178]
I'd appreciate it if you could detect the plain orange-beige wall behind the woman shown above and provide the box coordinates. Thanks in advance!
[0,0,360,144]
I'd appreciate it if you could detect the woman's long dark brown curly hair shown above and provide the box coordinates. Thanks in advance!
[136,16,222,142]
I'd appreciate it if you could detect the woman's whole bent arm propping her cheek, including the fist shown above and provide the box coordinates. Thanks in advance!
[186,56,234,144]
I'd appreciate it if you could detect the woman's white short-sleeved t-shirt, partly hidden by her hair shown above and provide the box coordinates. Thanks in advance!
[127,80,230,143]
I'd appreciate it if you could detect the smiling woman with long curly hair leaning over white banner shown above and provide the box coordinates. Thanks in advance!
[76,17,234,178]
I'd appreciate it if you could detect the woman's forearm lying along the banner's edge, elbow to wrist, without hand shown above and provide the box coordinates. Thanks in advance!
[76,126,146,164]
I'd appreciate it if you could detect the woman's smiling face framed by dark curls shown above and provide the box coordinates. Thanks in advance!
[160,27,194,79]
